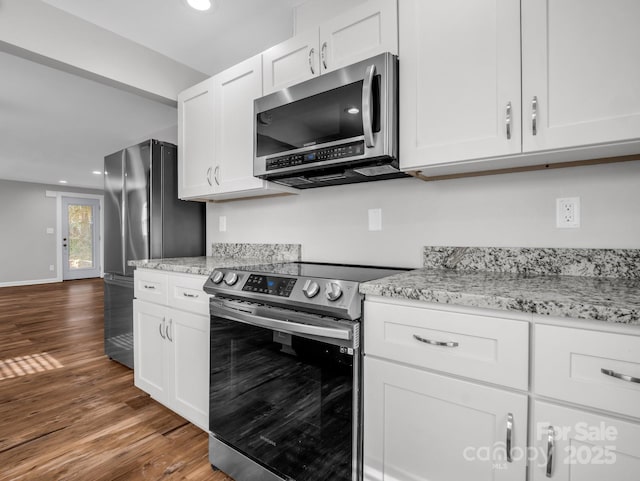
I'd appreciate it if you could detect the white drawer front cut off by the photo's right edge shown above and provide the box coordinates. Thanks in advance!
[534,324,640,418]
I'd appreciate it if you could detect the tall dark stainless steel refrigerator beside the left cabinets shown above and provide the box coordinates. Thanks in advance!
[104,140,205,369]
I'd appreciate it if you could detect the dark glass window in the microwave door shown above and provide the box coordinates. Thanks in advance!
[256,81,377,157]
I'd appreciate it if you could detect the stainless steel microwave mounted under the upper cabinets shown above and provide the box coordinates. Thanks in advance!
[253,53,406,189]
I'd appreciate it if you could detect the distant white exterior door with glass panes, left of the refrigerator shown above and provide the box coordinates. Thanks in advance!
[61,197,100,281]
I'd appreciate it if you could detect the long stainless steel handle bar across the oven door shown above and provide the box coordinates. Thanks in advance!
[211,301,353,341]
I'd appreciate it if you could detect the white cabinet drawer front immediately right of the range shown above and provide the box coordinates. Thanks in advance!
[364,301,529,390]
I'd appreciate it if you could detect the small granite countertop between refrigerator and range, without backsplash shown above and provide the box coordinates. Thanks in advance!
[128,256,265,276]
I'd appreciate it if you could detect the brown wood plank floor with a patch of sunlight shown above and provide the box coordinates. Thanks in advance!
[0,279,233,481]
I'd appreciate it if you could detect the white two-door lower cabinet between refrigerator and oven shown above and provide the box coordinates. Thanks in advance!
[133,271,209,431]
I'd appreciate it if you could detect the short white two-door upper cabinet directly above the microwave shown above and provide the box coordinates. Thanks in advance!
[263,0,398,95]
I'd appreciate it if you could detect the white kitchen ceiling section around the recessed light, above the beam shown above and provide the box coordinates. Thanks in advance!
[43,0,305,75]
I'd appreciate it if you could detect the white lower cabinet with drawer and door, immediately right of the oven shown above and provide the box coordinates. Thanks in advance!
[363,298,529,481]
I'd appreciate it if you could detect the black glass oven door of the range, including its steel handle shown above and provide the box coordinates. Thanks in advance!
[209,299,359,481]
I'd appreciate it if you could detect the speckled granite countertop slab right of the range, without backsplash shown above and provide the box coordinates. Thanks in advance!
[360,268,640,326]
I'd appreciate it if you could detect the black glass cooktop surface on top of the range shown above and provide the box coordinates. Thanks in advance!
[233,262,409,282]
